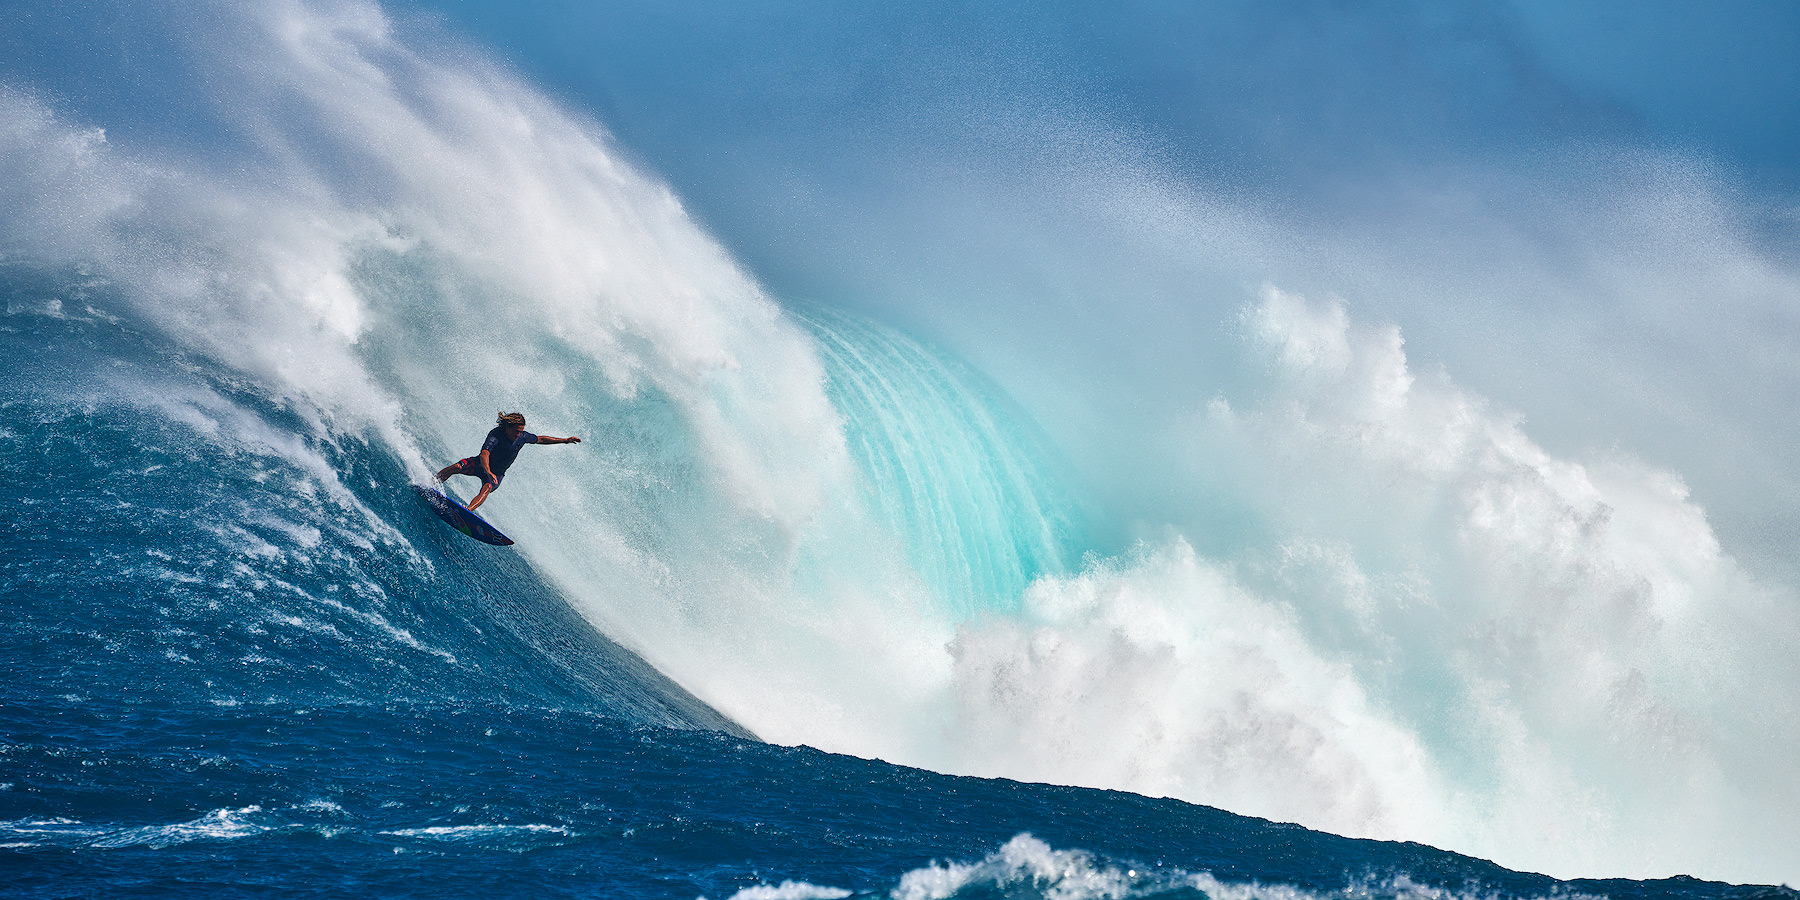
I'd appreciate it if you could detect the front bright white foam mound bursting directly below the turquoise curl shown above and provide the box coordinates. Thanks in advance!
[952,538,1449,837]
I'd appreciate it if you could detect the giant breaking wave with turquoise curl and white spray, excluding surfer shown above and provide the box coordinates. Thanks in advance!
[0,2,1800,880]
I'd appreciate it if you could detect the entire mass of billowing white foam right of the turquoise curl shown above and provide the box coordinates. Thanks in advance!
[952,288,1800,873]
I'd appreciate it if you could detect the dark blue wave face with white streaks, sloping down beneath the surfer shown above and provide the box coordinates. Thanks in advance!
[0,265,742,731]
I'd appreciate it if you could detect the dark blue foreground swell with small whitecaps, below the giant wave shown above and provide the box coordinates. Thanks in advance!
[0,700,1793,900]
